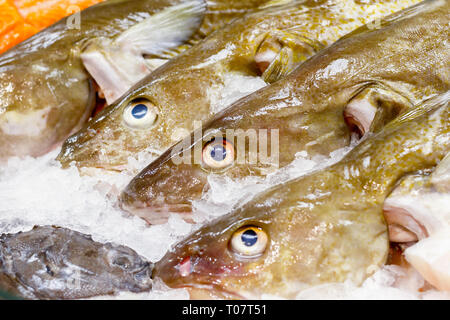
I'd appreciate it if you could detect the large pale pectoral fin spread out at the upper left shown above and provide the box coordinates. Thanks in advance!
[81,0,206,104]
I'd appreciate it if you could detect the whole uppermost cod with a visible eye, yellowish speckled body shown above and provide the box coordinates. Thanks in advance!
[58,0,419,171]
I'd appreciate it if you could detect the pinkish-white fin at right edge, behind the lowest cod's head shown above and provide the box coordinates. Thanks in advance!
[384,154,450,291]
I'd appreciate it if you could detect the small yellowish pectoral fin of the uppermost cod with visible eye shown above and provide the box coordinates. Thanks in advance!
[255,30,324,83]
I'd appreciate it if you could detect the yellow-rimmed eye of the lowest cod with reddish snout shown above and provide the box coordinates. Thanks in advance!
[231,226,268,258]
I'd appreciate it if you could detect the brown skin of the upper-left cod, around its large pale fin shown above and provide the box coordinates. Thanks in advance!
[0,0,263,160]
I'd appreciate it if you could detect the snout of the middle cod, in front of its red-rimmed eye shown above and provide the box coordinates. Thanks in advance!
[119,163,207,224]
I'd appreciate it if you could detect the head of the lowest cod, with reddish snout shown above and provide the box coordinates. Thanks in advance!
[153,174,388,299]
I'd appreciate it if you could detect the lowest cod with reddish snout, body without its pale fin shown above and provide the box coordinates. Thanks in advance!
[153,92,450,298]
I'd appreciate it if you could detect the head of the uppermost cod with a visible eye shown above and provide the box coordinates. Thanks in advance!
[58,53,225,171]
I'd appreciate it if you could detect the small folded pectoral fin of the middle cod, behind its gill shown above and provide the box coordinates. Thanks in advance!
[344,85,412,136]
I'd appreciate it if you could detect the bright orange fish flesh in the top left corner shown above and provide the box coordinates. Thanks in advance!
[0,0,103,54]
